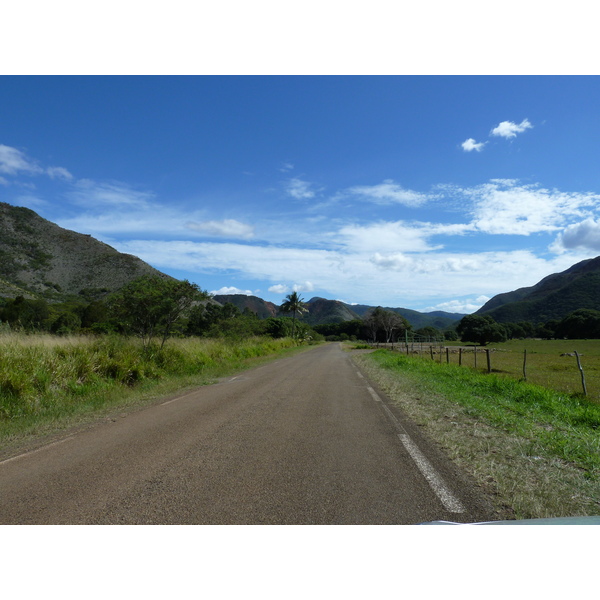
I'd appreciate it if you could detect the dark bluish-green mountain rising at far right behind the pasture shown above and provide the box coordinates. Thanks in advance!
[475,256,600,323]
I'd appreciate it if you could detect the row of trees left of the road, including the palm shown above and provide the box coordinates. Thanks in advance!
[0,276,322,347]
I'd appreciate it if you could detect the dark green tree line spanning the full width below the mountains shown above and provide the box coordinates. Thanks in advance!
[0,276,600,347]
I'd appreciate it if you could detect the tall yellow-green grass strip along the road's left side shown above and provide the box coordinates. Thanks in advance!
[0,335,295,444]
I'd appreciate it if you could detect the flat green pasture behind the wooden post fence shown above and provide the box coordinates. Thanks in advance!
[400,340,600,401]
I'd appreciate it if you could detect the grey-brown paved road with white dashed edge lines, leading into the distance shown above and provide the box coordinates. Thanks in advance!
[0,344,490,524]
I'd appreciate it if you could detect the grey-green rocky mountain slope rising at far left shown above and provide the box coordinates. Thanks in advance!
[0,202,168,300]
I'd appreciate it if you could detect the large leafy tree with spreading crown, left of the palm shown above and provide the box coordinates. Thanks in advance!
[108,275,208,349]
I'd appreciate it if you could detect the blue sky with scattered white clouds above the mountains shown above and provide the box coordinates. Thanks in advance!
[0,75,600,312]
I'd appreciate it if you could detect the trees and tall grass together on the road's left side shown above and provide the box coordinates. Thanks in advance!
[0,276,323,442]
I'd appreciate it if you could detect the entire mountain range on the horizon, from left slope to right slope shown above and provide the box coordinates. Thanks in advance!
[0,202,600,329]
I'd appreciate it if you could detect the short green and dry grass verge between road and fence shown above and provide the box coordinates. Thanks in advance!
[354,350,600,518]
